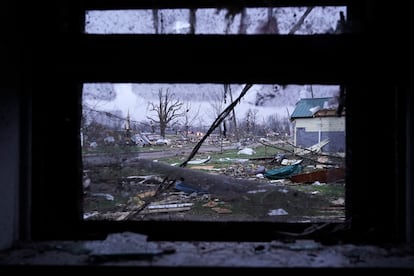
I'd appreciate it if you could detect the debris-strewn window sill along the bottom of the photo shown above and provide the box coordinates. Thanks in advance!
[0,232,414,270]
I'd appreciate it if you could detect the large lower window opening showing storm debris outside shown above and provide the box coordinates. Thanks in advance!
[80,83,346,223]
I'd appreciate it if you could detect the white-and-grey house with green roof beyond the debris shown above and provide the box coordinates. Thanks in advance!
[290,97,345,153]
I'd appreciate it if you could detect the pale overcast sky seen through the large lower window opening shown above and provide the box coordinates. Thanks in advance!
[84,83,339,124]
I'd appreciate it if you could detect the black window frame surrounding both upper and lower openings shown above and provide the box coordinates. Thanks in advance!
[28,0,404,243]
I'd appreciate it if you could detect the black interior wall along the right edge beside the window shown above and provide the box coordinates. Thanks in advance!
[347,1,413,244]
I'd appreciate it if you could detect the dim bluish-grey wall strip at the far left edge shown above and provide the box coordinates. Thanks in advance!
[0,1,21,249]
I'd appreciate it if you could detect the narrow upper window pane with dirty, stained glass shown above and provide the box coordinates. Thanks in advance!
[84,6,347,35]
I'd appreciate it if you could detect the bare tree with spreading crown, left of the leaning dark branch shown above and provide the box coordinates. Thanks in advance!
[147,88,184,138]
